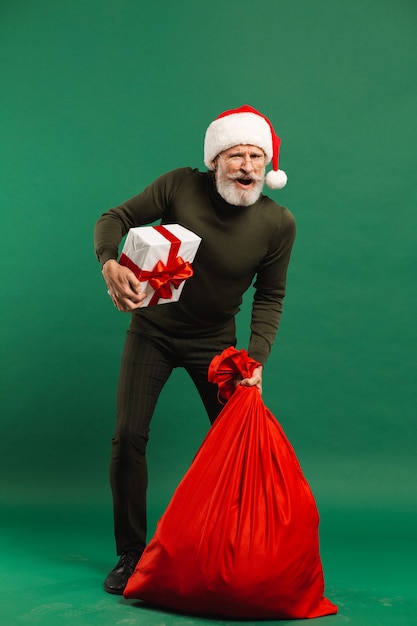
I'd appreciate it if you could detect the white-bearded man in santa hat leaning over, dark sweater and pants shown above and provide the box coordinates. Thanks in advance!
[95,105,295,594]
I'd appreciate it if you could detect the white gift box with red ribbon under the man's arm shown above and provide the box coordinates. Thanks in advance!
[119,224,201,306]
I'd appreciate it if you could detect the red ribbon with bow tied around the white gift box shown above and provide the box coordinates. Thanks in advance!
[119,226,193,306]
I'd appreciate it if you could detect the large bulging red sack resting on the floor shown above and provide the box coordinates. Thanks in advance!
[124,348,337,619]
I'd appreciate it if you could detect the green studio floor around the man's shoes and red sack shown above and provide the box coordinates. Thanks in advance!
[0,504,417,626]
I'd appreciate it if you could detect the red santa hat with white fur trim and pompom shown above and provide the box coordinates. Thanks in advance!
[204,104,287,189]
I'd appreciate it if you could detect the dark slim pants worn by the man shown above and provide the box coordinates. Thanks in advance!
[110,324,236,554]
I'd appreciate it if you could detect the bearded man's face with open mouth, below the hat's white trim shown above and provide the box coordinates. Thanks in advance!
[213,145,266,206]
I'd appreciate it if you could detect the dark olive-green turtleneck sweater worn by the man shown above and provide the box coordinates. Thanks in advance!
[94,168,295,364]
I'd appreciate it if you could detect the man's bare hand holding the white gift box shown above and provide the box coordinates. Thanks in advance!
[102,259,146,313]
